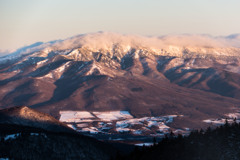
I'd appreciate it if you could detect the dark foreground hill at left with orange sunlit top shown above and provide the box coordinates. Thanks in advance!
[0,106,116,160]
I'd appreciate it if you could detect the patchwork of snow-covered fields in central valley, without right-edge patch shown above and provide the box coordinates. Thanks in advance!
[60,111,189,137]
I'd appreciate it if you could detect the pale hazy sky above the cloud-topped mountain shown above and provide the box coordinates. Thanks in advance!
[0,0,240,52]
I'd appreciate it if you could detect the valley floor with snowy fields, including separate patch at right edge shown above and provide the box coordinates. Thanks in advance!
[60,111,240,146]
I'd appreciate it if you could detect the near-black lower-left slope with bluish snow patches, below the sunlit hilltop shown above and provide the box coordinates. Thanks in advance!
[0,126,115,160]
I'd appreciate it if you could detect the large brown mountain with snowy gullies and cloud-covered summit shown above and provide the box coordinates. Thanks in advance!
[0,33,240,130]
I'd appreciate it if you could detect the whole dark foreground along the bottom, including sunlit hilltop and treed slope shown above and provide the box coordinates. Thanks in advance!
[0,107,240,160]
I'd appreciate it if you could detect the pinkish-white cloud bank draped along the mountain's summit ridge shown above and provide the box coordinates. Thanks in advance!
[0,32,240,55]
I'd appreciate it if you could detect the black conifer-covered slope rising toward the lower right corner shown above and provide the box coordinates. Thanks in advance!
[123,122,240,160]
